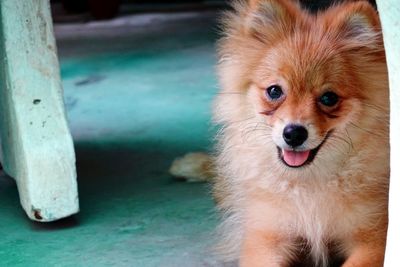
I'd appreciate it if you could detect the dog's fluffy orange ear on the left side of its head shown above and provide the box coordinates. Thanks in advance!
[242,0,302,38]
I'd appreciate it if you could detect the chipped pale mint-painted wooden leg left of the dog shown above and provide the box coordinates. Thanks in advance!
[0,0,79,221]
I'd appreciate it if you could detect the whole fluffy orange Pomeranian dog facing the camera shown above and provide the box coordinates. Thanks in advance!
[214,0,389,267]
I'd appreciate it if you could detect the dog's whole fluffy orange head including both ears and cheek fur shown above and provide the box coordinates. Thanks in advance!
[217,0,387,172]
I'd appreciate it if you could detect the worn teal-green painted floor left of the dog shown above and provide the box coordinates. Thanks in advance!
[0,12,225,266]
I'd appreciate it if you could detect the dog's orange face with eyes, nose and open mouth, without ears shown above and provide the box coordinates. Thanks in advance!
[250,35,363,167]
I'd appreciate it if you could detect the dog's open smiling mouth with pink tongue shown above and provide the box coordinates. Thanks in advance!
[277,131,331,168]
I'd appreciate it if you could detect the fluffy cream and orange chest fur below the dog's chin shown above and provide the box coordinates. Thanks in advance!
[215,135,388,263]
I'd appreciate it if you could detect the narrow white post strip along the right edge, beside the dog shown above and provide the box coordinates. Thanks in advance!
[377,0,400,267]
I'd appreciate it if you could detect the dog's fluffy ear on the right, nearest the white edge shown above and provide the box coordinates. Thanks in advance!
[328,1,381,46]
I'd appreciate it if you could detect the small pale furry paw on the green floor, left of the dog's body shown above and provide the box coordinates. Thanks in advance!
[169,152,213,182]
